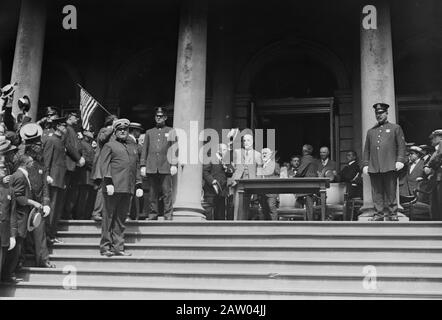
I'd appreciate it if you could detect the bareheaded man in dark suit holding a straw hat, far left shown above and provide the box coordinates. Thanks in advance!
[2,154,43,282]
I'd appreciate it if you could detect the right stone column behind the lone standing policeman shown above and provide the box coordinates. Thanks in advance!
[360,0,396,218]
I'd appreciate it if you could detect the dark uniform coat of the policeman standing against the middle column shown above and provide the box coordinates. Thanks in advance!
[140,126,175,174]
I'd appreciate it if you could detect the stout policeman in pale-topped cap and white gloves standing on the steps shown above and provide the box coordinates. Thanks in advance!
[100,119,143,257]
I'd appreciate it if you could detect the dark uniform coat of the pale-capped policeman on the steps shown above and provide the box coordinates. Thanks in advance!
[100,139,141,194]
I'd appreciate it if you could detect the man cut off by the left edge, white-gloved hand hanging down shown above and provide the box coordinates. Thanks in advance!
[0,140,17,282]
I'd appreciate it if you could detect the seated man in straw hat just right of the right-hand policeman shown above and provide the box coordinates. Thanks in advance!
[399,146,424,197]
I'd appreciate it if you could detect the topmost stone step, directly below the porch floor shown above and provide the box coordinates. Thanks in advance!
[59,220,442,235]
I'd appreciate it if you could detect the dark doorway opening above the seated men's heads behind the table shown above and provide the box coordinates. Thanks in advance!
[260,113,331,164]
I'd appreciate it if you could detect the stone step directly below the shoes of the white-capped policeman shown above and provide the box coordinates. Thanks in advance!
[28,254,442,275]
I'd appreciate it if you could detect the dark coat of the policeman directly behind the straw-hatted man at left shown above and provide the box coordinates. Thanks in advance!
[43,134,66,189]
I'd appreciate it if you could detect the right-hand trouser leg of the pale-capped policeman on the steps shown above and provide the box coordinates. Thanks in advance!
[110,193,132,252]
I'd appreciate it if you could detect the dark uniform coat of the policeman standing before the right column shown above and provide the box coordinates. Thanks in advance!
[362,122,406,173]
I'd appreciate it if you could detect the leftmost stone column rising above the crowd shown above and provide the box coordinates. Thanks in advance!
[11,0,46,121]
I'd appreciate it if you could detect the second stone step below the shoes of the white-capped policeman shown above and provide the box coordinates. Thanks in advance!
[12,268,442,293]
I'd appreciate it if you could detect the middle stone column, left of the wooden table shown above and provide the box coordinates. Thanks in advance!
[173,0,207,220]
